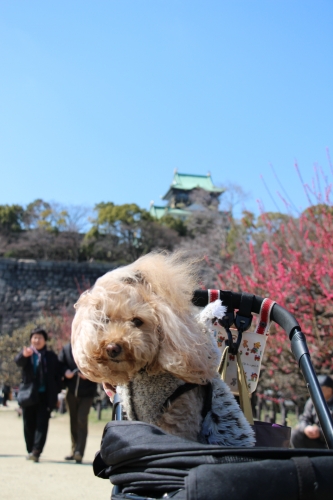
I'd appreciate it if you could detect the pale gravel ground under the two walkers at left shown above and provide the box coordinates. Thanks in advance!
[0,401,111,500]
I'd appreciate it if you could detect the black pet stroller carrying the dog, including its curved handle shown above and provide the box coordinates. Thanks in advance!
[94,290,333,500]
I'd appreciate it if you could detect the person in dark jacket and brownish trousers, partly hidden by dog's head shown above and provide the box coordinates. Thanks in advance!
[59,344,97,463]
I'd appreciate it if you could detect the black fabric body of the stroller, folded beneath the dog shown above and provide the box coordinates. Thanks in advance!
[94,421,333,500]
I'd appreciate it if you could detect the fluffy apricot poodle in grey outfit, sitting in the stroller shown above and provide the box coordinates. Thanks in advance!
[72,253,254,446]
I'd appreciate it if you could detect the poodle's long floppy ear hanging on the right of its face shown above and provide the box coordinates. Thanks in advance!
[148,303,217,384]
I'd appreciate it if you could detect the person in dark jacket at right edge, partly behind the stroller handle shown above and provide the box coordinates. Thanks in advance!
[291,375,333,448]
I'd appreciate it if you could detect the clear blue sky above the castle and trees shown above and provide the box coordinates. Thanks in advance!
[0,0,333,217]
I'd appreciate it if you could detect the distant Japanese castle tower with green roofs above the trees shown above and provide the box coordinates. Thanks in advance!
[150,170,225,220]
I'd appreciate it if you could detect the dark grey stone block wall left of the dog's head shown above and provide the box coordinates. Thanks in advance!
[0,259,114,334]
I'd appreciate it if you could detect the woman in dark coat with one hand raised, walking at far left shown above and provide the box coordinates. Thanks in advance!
[15,328,61,462]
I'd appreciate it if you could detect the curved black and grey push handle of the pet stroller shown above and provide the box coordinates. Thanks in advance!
[192,290,333,449]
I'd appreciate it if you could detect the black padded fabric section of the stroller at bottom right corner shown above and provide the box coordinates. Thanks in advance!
[185,456,333,500]
